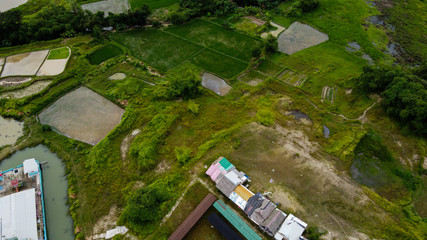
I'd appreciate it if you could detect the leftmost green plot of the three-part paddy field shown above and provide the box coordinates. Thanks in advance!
[112,29,203,72]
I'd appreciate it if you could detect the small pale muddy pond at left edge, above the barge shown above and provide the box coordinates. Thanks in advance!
[0,116,24,147]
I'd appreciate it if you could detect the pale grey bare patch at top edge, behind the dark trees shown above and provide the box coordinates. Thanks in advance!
[82,0,130,17]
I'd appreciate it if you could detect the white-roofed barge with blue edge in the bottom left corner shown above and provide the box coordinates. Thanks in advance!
[0,158,47,240]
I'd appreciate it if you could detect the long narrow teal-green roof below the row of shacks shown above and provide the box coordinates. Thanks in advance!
[213,200,262,240]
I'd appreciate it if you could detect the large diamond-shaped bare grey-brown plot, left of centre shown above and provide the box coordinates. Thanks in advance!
[39,87,124,145]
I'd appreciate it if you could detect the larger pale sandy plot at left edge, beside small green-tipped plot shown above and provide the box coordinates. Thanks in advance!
[1,50,49,77]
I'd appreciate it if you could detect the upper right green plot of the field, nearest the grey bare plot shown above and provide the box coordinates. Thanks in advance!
[165,19,261,62]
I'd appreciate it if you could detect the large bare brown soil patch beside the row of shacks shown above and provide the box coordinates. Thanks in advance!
[229,123,384,239]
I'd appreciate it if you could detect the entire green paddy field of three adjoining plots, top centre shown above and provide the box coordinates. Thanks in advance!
[112,19,261,78]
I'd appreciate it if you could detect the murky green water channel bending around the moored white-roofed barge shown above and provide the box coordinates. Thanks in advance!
[0,145,74,240]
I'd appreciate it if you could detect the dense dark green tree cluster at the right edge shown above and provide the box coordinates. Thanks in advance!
[357,66,427,136]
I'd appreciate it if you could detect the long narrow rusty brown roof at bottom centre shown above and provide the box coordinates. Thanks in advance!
[168,193,216,240]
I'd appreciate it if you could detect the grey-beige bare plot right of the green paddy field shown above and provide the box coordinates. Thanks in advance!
[278,22,329,55]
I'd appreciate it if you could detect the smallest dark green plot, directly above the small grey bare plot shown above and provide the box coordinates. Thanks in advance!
[190,49,247,79]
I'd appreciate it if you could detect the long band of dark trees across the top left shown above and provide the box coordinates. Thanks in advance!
[0,4,150,47]
